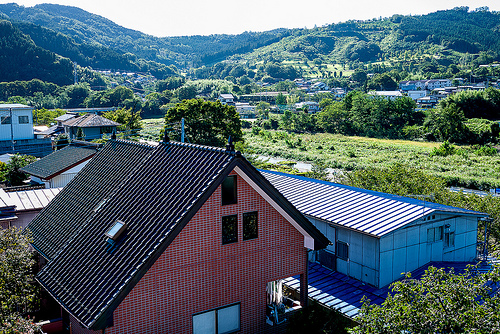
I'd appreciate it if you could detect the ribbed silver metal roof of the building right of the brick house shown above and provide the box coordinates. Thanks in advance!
[261,171,486,237]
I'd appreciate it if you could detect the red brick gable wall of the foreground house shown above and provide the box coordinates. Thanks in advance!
[72,171,306,334]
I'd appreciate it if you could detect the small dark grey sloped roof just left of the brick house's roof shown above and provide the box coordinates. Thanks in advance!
[21,140,99,180]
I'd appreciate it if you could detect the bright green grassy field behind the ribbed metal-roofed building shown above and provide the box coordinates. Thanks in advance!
[245,130,500,190]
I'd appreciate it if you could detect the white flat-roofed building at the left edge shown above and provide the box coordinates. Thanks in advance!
[0,104,52,157]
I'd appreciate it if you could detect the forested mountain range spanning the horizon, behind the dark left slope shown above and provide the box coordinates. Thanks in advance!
[0,4,500,87]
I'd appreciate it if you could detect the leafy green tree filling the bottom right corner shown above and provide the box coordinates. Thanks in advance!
[352,266,500,334]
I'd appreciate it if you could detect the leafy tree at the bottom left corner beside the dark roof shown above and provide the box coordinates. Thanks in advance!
[0,227,37,333]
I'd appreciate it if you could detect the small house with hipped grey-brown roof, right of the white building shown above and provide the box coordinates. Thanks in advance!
[62,114,120,141]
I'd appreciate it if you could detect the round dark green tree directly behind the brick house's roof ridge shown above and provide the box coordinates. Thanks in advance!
[165,99,243,147]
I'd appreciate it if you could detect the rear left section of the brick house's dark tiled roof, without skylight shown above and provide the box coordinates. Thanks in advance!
[24,141,153,259]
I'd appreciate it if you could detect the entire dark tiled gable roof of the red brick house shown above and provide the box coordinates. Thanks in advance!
[28,140,329,329]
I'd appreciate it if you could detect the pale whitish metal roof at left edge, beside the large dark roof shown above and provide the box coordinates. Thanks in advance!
[0,188,62,212]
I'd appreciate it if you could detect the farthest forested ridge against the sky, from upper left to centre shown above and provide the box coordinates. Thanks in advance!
[0,4,289,67]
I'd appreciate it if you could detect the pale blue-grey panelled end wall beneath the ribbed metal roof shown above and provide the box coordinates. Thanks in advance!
[379,215,477,287]
